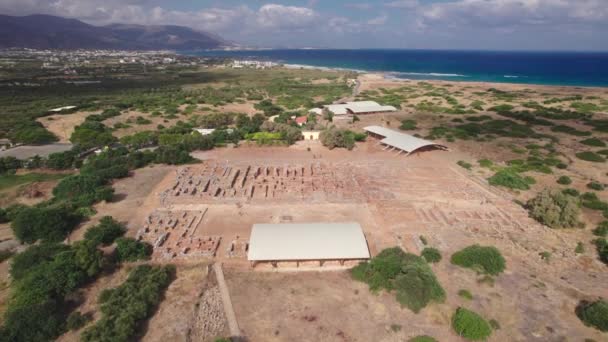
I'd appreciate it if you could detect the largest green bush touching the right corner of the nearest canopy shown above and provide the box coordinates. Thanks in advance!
[351,247,445,313]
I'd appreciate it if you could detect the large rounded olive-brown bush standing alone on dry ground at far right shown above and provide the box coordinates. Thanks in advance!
[526,189,580,228]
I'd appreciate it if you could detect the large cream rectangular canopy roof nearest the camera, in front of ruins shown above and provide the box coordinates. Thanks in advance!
[247,223,369,261]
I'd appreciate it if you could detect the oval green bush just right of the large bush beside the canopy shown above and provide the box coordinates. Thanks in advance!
[451,245,506,275]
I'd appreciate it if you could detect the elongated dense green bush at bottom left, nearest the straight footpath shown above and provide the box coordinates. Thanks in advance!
[81,265,175,342]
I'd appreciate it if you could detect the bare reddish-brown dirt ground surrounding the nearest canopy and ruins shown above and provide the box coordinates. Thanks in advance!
[115,140,608,341]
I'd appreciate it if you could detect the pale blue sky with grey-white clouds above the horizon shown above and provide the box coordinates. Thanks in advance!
[0,0,608,51]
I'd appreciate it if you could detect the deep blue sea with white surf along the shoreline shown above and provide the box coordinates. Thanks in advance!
[180,49,608,87]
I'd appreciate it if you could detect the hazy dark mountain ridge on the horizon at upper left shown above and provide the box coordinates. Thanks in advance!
[0,15,231,50]
